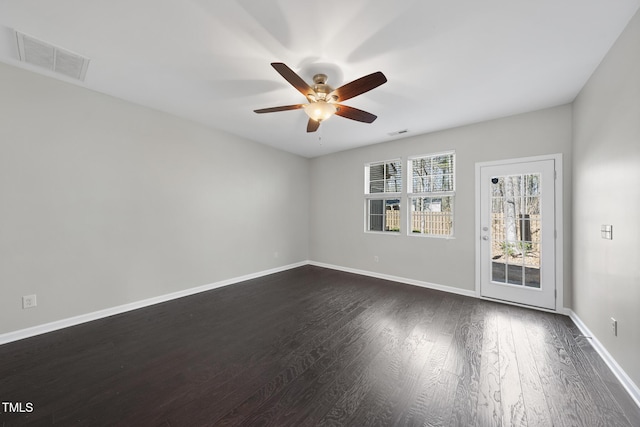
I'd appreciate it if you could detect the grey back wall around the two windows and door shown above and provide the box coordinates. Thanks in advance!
[310,105,572,305]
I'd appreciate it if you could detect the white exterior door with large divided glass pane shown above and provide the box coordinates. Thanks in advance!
[478,159,556,309]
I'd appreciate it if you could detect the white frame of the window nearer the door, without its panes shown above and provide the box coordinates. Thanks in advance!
[405,150,457,239]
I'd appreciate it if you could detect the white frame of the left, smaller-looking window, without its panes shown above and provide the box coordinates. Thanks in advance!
[364,157,404,235]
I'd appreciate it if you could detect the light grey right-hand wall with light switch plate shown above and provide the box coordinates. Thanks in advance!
[573,13,640,384]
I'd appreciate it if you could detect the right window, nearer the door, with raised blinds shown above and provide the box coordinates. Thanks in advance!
[407,152,455,237]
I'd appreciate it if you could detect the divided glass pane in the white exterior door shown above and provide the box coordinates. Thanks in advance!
[490,174,542,288]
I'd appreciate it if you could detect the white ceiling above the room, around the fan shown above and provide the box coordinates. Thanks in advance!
[0,0,640,157]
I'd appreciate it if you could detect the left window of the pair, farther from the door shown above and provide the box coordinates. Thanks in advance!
[364,159,402,233]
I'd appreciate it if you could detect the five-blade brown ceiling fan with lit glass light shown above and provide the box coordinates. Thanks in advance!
[253,62,387,132]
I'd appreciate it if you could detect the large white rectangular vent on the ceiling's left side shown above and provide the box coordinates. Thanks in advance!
[16,31,89,81]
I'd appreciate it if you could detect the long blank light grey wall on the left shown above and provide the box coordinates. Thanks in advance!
[0,64,309,333]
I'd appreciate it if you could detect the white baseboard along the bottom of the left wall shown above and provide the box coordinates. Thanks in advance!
[0,261,309,345]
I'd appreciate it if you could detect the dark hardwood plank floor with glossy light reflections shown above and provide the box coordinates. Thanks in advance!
[0,266,640,427]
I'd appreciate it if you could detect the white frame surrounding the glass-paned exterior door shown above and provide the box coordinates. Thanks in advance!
[473,153,566,313]
